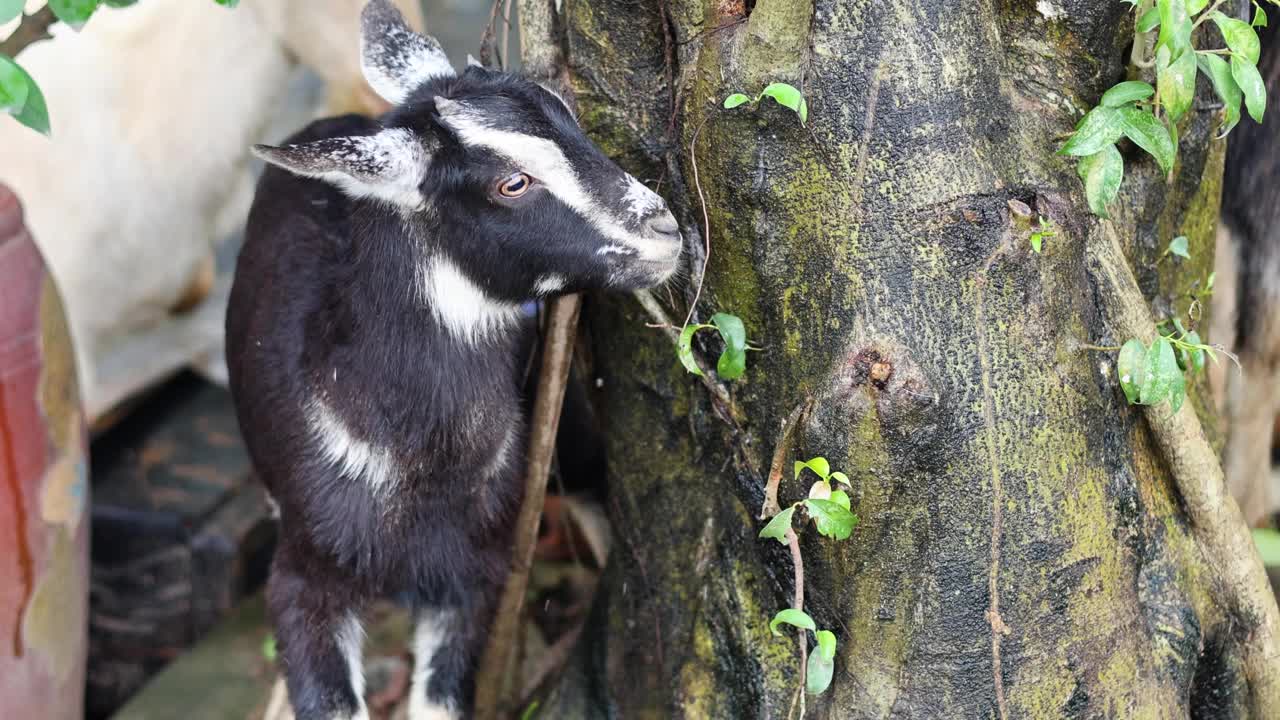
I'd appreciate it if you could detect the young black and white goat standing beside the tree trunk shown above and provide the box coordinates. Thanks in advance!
[227,0,681,720]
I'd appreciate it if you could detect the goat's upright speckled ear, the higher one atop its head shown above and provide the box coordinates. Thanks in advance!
[360,0,457,105]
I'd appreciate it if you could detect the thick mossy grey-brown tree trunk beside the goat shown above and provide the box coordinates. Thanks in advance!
[544,0,1274,719]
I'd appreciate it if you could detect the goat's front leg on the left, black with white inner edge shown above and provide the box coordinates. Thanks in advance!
[268,544,369,720]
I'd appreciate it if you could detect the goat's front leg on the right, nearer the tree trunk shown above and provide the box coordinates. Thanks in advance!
[408,573,502,720]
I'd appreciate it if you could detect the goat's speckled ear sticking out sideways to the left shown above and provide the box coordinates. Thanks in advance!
[253,128,430,209]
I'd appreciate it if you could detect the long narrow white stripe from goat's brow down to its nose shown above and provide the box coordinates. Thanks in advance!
[435,97,678,261]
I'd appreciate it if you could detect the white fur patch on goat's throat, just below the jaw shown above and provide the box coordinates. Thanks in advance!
[420,256,520,345]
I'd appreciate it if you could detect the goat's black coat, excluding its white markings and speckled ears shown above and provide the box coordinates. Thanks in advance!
[227,58,669,720]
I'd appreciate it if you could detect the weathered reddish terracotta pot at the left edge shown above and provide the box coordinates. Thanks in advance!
[0,184,88,720]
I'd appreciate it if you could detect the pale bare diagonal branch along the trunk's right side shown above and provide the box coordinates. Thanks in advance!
[1087,220,1280,717]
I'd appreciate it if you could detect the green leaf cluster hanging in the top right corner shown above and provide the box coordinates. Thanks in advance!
[1059,0,1280,218]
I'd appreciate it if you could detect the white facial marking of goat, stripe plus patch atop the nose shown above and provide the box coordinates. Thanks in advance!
[435,96,680,263]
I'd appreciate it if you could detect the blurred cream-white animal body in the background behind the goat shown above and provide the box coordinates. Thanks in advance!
[0,0,420,407]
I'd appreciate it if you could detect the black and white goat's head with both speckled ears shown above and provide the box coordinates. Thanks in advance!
[255,0,682,311]
